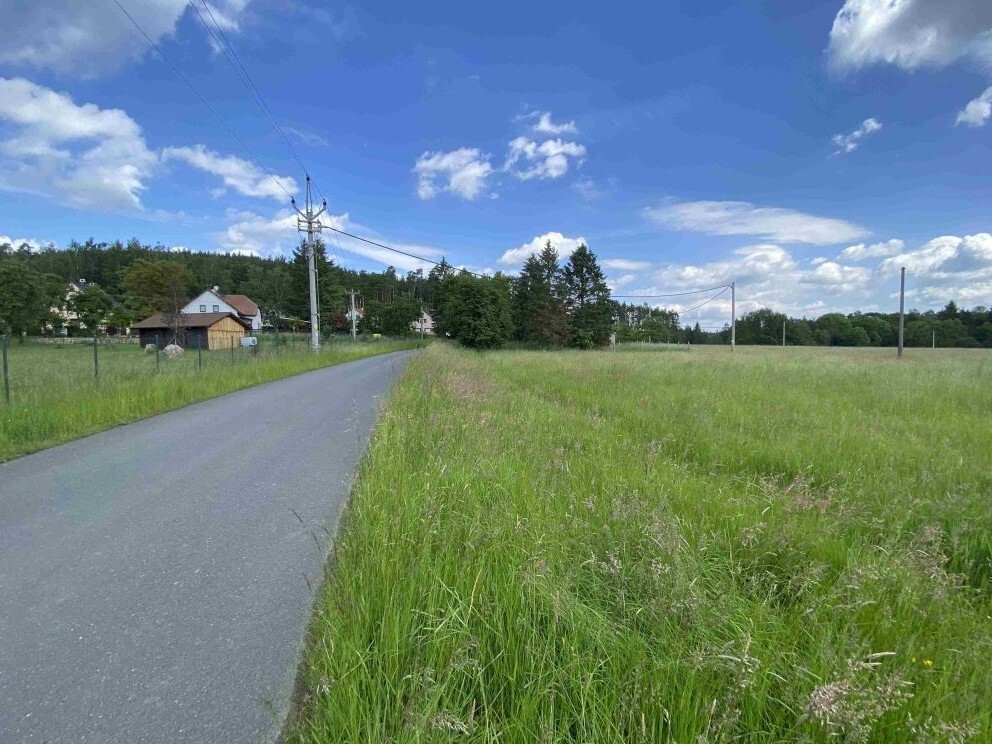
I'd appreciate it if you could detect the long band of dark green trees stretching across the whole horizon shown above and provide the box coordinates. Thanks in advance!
[0,240,992,348]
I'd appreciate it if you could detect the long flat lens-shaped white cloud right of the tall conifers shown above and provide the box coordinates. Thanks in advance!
[644,201,869,245]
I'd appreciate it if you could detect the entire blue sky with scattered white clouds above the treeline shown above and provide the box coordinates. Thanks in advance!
[0,0,992,326]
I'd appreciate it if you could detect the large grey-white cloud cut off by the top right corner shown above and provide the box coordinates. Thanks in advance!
[828,0,992,70]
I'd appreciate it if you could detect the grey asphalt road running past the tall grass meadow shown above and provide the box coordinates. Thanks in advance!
[0,354,405,744]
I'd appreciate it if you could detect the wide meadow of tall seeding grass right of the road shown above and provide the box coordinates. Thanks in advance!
[286,345,992,744]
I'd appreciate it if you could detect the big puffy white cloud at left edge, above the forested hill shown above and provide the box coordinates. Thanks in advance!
[0,78,157,210]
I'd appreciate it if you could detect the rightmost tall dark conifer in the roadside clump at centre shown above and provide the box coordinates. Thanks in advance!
[564,245,613,349]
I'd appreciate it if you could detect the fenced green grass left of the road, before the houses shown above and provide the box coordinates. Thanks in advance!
[0,336,421,462]
